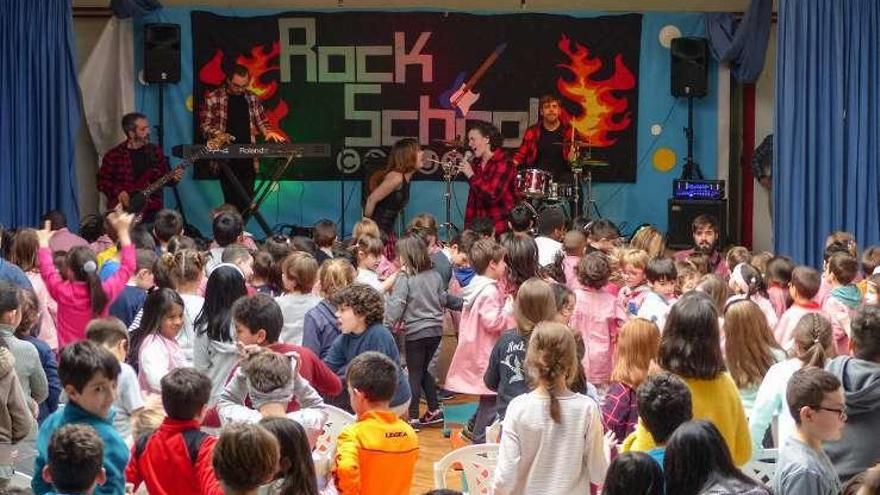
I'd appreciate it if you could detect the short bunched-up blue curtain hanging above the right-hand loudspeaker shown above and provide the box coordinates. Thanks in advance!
[706,0,773,83]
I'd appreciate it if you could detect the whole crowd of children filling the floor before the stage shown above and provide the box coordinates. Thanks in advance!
[0,203,880,495]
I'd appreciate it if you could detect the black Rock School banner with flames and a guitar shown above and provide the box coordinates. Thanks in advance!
[191,11,644,182]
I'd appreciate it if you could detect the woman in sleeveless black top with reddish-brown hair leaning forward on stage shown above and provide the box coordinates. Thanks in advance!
[364,138,423,238]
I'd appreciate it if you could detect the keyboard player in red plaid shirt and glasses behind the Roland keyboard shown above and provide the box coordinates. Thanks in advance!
[199,65,284,212]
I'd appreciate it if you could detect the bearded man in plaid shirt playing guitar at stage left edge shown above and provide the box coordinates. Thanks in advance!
[98,112,183,224]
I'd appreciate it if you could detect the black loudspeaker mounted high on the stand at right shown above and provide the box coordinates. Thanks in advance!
[669,38,709,97]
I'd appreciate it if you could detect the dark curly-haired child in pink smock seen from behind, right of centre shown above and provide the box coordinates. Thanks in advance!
[571,251,625,389]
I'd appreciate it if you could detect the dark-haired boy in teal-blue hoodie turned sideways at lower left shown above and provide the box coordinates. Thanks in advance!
[31,341,128,495]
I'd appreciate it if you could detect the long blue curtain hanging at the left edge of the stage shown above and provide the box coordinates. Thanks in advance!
[0,0,80,231]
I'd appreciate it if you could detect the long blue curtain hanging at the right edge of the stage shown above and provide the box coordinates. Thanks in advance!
[773,0,880,267]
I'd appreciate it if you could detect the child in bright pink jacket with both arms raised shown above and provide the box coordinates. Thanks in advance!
[37,213,136,348]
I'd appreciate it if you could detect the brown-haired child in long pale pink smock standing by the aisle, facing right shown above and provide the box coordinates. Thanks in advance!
[444,239,514,443]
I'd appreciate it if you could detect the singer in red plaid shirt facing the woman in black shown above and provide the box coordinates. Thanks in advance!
[461,120,516,234]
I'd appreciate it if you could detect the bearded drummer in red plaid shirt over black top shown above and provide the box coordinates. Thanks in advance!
[513,94,574,184]
